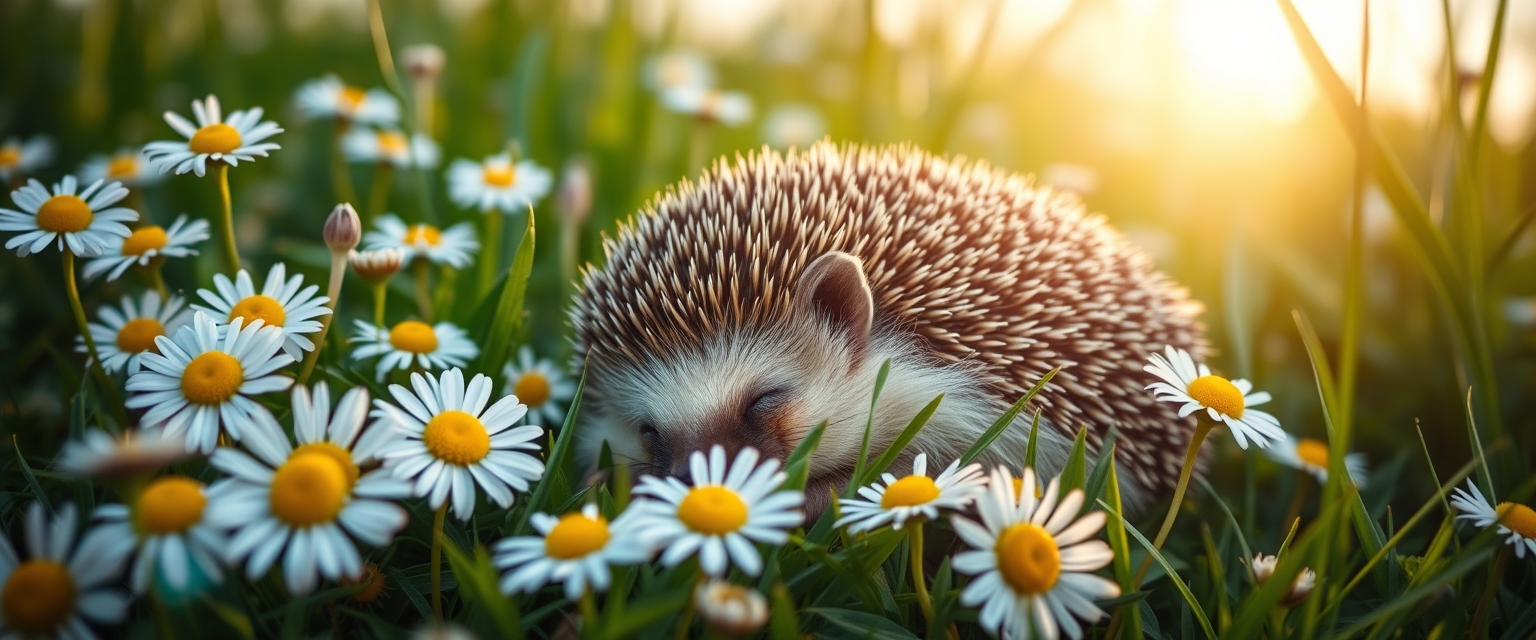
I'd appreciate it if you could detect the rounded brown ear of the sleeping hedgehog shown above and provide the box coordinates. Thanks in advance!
[794,252,874,368]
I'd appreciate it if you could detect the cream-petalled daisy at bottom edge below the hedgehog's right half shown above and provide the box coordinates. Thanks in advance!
[951,467,1120,638]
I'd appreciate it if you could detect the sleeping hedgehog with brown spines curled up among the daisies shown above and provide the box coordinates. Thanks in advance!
[570,141,1204,511]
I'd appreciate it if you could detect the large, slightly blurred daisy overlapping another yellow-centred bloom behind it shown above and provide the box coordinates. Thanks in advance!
[209,382,410,595]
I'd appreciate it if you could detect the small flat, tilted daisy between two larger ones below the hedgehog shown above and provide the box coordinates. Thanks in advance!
[836,453,986,533]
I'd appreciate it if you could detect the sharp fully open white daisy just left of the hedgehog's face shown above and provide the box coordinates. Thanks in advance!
[370,367,544,520]
